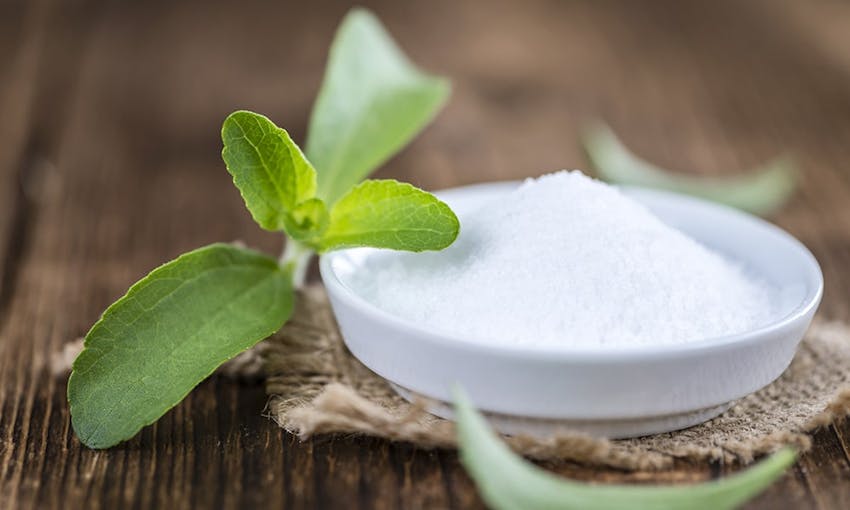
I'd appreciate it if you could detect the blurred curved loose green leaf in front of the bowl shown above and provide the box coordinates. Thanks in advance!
[453,388,796,510]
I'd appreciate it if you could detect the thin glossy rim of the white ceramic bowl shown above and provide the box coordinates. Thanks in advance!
[319,181,824,363]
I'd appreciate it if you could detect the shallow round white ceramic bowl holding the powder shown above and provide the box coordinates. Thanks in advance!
[320,182,823,437]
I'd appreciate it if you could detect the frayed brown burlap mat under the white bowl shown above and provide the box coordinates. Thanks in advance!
[260,285,850,470]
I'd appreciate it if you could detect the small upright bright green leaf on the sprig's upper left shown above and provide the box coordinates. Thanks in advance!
[221,111,316,231]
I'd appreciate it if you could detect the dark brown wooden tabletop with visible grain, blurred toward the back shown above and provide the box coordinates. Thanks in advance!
[0,0,850,508]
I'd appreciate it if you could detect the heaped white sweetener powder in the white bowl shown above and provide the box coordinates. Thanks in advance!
[346,171,772,349]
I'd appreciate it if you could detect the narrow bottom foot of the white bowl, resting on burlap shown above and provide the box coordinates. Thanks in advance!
[390,383,732,439]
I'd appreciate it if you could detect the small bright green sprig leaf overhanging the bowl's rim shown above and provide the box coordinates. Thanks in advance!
[319,180,460,251]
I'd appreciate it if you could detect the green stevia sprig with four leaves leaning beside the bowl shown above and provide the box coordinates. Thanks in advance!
[68,9,460,448]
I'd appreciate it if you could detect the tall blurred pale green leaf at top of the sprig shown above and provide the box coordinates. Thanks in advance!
[306,9,449,204]
